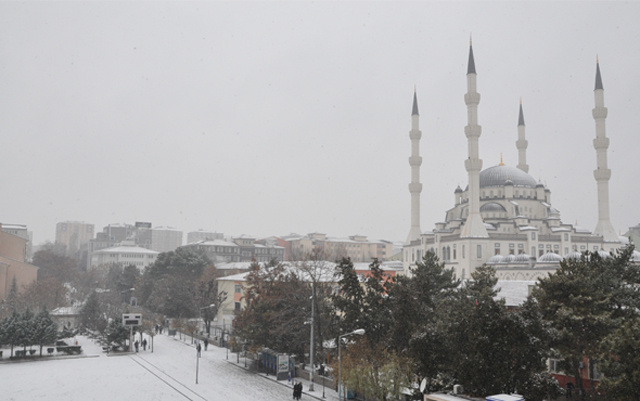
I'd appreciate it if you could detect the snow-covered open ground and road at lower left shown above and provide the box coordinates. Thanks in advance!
[0,335,338,401]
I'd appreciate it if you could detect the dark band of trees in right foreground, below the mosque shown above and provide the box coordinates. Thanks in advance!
[235,247,640,400]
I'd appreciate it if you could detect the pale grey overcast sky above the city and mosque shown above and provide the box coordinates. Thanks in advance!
[0,1,640,244]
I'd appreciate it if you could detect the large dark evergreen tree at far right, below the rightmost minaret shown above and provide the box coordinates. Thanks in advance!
[533,246,640,394]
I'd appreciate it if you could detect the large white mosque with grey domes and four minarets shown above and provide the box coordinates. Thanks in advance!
[402,44,624,281]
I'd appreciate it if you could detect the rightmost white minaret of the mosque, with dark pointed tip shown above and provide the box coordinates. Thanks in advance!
[592,59,619,242]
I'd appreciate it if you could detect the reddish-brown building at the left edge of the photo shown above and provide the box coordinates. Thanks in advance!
[0,224,38,300]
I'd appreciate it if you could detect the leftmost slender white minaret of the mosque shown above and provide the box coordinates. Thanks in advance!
[407,88,422,244]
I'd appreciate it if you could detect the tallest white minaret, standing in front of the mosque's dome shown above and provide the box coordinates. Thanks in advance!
[460,42,489,238]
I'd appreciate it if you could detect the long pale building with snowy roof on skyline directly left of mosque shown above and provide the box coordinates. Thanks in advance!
[282,233,393,262]
